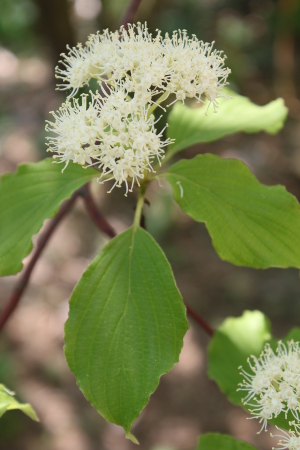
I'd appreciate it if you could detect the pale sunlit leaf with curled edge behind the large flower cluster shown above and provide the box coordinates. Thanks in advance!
[168,89,288,155]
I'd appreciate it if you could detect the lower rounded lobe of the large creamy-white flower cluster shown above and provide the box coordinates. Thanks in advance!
[46,90,171,195]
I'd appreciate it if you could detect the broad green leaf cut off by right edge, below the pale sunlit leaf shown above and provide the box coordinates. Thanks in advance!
[164,154,300,268]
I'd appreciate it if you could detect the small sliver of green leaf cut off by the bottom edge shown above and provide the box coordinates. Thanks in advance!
[197,433,255,450]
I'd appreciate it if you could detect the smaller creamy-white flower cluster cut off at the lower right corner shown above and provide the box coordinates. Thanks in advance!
[238,341,300,450]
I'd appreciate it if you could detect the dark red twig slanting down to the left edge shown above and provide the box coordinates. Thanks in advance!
[0,191,80,330]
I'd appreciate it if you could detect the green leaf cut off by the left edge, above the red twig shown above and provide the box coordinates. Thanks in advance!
[0,158,97,276]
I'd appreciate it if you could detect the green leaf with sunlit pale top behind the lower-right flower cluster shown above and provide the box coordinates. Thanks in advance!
[208,311,300,428]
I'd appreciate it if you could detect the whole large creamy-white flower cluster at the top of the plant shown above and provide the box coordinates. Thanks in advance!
[47,23,230,195]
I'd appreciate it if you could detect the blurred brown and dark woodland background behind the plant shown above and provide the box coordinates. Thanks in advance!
[0,0,300,450]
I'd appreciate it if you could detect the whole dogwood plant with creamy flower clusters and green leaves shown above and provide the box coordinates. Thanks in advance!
[0,23,300,448]
